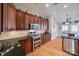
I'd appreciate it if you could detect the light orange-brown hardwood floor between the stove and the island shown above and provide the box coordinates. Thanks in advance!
[27,38,71,56]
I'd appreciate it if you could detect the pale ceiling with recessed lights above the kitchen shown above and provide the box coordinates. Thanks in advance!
[15,3,79,23]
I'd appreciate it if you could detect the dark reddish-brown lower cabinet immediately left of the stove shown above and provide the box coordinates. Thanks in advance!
[19,38,33,54]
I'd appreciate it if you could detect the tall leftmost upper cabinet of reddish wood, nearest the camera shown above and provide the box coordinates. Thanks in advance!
[3,3,16,31]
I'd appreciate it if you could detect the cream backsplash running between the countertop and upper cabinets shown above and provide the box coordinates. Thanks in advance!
[0,30,45,40]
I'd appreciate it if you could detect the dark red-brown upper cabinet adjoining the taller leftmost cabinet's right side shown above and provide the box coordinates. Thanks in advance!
[16,10,25,30]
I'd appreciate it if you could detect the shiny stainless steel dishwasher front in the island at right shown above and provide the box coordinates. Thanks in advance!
[63,38,78,55]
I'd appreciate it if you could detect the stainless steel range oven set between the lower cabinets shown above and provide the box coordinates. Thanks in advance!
[29,31,41,51]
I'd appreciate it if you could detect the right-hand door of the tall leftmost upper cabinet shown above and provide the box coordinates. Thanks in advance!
[7,5,16,30]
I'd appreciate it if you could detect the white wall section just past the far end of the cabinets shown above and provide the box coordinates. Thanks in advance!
[49,16,58,40]
